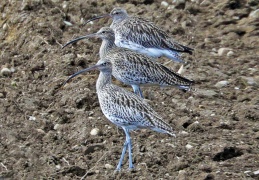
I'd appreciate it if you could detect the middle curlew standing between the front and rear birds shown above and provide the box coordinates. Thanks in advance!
[63,27,194,98]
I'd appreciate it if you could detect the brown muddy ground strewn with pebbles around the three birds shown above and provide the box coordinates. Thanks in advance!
[0,0,259,180]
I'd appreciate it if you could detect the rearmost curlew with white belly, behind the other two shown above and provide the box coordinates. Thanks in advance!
[85,7,194,63]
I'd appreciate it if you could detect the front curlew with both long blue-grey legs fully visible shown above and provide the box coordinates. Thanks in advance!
[63,59,176,171]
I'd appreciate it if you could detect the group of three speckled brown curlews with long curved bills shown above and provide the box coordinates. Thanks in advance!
[63,8,194,171]
